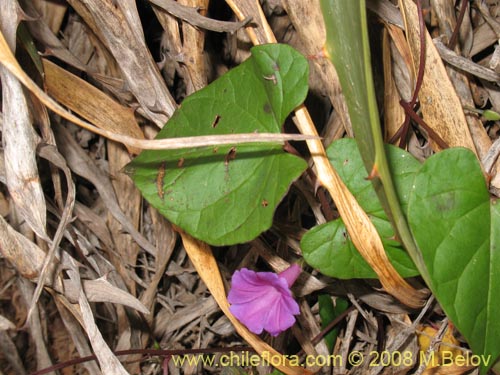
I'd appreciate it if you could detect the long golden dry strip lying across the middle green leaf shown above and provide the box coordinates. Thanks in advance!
[226,0,427,308]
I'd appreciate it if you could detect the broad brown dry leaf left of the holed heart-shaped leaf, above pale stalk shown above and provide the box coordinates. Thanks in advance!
[42,59,144,154]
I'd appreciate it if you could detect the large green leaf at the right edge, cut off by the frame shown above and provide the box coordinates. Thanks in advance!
[408,148,500,373]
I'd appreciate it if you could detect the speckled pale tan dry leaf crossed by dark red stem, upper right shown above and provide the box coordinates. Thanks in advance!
[399,0,477,154]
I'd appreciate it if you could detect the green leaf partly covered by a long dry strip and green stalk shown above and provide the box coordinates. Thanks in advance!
[301,139,420,279]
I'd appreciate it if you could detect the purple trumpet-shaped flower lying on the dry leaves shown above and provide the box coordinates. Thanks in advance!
[227,264,301,336]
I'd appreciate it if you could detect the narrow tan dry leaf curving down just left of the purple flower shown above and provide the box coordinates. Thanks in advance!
[176,229,311,375]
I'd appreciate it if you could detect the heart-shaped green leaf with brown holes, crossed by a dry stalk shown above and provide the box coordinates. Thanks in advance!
[127,44,308,245]
